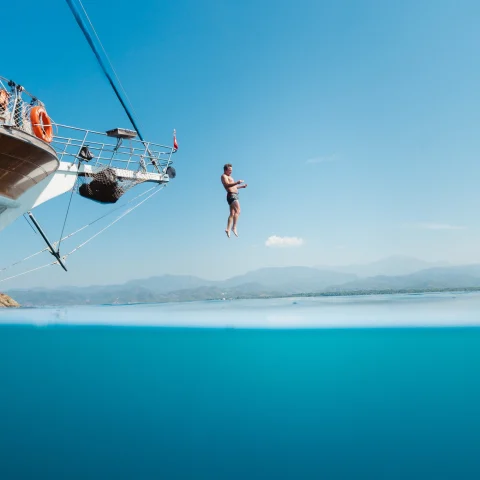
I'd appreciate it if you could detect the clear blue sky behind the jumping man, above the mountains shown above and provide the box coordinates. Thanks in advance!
[0,0,480,289]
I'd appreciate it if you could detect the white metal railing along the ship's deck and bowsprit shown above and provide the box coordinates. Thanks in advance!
[0,77,176,173]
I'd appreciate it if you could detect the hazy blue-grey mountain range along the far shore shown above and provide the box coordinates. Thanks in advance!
[5,256,480,306]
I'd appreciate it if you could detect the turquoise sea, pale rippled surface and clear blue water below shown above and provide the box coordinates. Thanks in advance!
[0,292,480,480]
